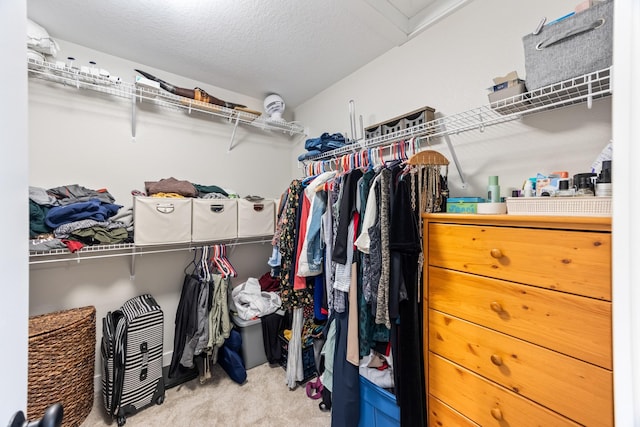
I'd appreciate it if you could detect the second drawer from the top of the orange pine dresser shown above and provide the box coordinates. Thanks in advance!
[428,267,612,369]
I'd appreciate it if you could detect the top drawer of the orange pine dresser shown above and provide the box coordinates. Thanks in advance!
[428,223,611,301]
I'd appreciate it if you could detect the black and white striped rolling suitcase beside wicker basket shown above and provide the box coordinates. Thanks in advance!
[101,294,165,426]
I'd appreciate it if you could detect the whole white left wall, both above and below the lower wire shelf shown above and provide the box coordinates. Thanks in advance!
[27,40,294,390]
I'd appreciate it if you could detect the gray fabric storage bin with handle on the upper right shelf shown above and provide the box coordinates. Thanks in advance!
[522,0,613,91]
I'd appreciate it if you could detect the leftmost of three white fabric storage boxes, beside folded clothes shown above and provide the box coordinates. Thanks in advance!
[133,196,191,246]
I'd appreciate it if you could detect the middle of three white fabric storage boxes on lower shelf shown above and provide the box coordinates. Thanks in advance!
[191,199,238,242]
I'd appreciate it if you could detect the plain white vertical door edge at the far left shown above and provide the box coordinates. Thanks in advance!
[0,1,29,425]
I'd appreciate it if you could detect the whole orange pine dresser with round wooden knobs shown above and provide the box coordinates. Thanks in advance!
[423,214,614,427]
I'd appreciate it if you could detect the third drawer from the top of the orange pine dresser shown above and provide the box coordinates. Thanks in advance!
[429,310,613,426]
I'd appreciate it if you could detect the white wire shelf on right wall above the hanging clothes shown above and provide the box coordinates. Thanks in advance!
[303,68,611,164]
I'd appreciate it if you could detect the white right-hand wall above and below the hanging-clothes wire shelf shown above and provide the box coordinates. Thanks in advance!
[292,0,611,197]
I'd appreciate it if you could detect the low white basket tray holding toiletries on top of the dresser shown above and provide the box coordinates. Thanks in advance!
[507,197,611,216]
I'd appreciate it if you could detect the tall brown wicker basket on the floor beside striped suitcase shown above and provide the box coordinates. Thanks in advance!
[27,306,96,427]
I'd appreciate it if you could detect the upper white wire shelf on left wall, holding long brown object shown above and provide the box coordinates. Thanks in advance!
[27,58,305,137]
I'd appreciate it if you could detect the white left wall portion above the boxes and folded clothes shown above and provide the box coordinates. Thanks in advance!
[29,41,295,204]
